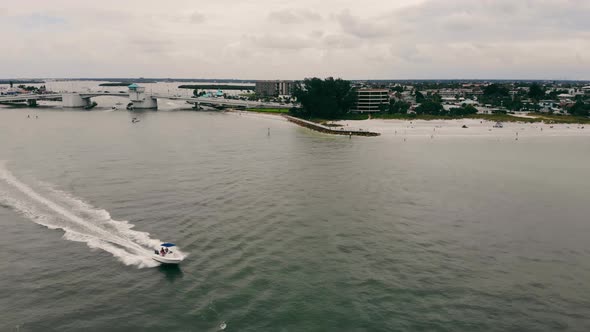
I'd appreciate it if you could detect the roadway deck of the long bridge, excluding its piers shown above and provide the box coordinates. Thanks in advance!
[0,92,294,108]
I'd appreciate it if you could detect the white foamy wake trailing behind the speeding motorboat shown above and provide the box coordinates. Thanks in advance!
[0,161,160,268]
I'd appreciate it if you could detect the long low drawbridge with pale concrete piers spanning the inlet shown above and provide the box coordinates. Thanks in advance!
[0,88,294,109]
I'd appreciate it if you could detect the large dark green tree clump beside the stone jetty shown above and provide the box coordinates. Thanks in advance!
[292,77,356,119]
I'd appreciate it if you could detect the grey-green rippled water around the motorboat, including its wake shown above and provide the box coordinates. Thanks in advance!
[0,92,590,331]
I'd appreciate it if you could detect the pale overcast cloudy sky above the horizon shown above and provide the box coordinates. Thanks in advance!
[0,0,590,79]
